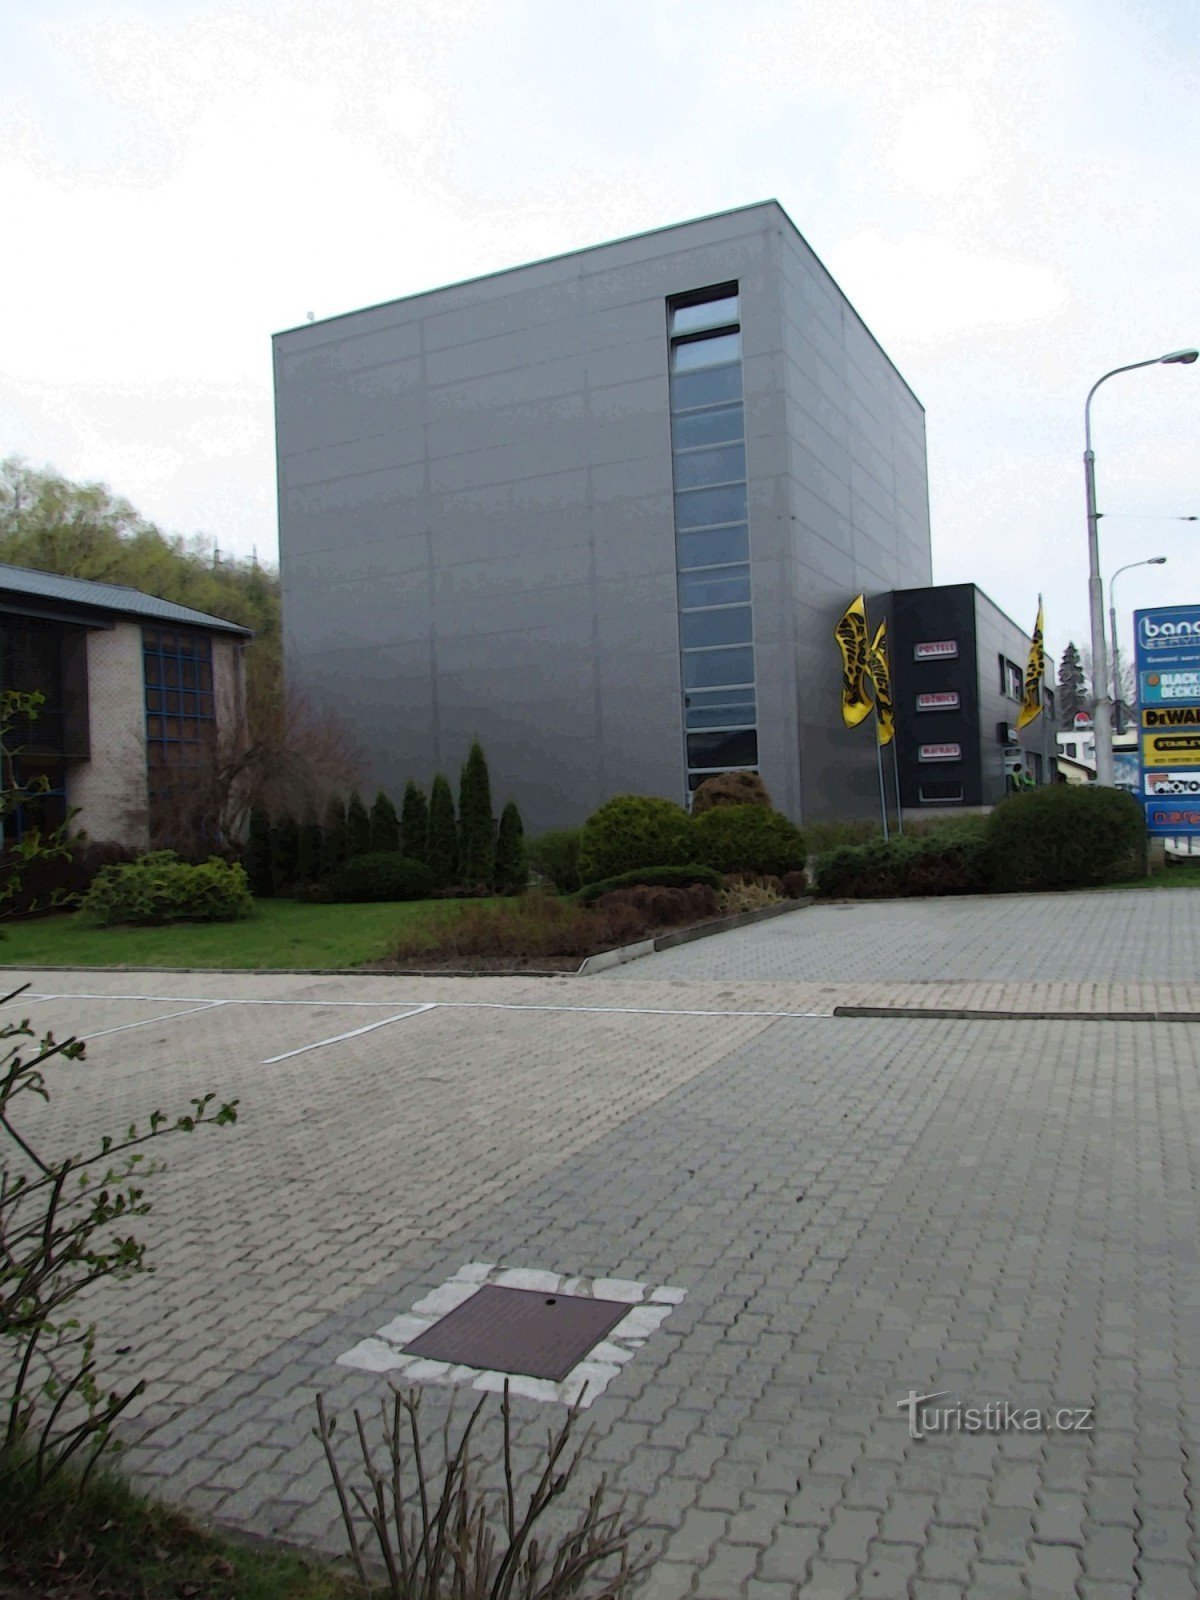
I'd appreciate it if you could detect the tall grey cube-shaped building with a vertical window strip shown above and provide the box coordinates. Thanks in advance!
[275,200,931,830]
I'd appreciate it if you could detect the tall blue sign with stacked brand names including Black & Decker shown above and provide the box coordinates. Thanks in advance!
[1133,605,1200,837]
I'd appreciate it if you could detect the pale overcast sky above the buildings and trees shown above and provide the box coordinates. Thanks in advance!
[0,0,1200,654]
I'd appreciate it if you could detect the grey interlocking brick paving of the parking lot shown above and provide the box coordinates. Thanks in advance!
[2,891,1200,1600]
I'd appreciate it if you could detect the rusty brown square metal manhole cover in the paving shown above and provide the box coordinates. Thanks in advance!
[403,1283,634,1382]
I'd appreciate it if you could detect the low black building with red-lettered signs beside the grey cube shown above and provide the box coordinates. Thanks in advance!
[888,584,1056,813]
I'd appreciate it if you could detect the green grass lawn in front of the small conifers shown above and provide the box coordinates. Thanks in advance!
[0,899,485,970]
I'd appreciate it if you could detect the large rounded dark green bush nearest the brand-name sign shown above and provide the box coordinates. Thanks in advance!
[987,784,1146,890]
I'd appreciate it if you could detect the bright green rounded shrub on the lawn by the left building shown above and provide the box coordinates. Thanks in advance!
[80,850,254,928]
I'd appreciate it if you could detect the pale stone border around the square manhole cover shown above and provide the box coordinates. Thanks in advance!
[338,1261,688,1410]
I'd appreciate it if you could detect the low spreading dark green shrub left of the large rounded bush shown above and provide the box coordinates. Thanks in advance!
[814,830,989,899]
